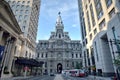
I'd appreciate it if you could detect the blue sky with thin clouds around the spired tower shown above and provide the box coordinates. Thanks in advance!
[37,0,81,42]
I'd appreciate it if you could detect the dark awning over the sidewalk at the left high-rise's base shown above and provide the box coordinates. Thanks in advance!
[15,57,44,67]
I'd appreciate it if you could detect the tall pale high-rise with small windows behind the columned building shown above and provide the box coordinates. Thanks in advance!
[6,0,41,58]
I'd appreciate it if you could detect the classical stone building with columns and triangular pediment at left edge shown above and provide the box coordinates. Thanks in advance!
[0,0,22,78]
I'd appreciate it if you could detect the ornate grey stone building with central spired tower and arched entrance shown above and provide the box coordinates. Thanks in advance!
[36,13,82,74]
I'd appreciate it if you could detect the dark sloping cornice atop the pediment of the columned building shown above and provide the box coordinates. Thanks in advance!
[0,0,22,34]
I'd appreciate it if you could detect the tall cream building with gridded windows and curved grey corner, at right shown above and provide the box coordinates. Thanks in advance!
[78,0,120,76]
